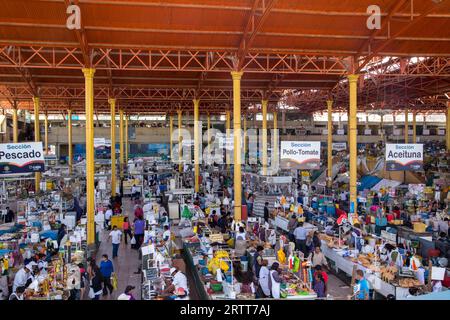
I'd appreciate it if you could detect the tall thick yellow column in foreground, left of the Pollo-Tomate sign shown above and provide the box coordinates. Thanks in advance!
[231,71,242,221]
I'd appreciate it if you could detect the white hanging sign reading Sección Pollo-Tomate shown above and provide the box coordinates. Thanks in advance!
[280,141,320,170]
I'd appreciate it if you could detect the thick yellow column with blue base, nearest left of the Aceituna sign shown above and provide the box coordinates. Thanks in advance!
[348,74,358,213]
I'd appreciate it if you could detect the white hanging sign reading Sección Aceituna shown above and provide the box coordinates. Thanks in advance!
[386,143,423,171]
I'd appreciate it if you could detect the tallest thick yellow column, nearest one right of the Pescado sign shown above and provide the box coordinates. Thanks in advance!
[83,68,95,246]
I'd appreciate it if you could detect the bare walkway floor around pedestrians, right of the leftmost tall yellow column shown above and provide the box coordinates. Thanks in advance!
[92,198,141,300]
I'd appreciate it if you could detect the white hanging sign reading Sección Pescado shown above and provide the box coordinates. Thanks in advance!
[0,142,45,174]
